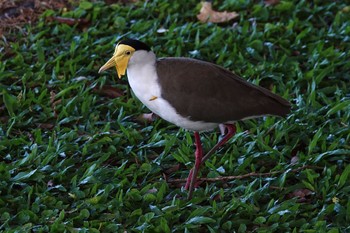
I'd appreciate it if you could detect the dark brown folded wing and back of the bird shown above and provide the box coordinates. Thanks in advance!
[157,58,290,123]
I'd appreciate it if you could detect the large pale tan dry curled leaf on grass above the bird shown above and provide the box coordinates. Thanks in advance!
[197,2,239,23]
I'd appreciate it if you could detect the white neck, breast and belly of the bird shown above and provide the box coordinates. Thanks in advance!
[127,51,218,131]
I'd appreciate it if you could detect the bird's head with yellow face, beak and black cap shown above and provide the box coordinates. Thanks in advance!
[98,39,150,78]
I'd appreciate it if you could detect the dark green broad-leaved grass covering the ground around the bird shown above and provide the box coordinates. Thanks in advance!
[0,0,350,233]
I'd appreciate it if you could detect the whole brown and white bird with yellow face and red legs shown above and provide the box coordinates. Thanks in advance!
[99,38,291,199]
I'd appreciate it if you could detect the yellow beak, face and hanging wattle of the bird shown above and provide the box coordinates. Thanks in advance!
[98,44,135,78]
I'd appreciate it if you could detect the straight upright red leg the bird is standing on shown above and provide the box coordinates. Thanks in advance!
[185,132,203,199]
